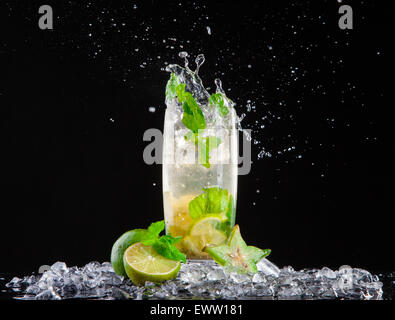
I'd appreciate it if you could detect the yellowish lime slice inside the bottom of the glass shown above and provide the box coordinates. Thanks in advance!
[181,214,227,259]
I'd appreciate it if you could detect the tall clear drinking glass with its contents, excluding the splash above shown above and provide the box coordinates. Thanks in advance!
[163,107,238,259]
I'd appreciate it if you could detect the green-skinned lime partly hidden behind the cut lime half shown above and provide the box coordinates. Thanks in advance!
[111,229,147,277]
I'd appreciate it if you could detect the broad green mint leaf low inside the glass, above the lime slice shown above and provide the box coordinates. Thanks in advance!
[188,187,232,219]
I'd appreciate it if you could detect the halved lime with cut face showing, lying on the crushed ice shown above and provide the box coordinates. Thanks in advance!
[123,242,181,285]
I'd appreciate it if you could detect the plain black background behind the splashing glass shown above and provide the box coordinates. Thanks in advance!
[0,1,394,273]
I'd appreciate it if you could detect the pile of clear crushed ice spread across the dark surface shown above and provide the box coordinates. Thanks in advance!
[6,259,383,300]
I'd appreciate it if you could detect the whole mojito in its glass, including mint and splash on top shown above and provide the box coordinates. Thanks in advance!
[163,55,238,259]
